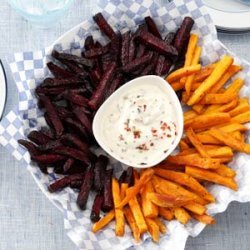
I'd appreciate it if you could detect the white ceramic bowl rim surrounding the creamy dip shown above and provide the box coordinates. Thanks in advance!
[93,75,183,168]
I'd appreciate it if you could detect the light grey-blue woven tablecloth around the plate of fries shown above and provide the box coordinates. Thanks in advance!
[0,0,250,250]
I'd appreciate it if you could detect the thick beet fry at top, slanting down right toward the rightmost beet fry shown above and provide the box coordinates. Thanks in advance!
[137,31,178,57]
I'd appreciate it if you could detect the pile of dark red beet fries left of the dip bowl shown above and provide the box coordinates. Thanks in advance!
[18,13,194,225]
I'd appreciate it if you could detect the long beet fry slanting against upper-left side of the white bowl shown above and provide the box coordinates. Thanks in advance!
[88,63,116,110]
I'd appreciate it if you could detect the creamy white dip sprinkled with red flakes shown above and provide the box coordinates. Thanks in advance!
[101,83,177,166]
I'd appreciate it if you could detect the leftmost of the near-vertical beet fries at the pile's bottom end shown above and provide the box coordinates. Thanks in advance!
[76,166,94,210]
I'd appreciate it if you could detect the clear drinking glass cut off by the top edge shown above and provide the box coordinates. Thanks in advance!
[8,0,74,28]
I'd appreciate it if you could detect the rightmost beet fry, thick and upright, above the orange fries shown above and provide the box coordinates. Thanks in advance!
[173,17,194,53]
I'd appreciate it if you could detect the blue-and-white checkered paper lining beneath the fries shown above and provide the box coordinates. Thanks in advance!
[0,0,250,250]
